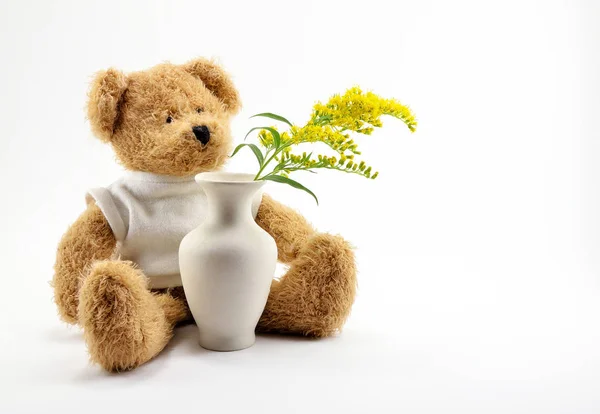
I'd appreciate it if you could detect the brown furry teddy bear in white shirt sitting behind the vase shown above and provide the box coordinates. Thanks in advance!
[53,58,356,371]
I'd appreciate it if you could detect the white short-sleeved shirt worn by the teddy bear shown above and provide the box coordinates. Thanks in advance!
[86,172,262,289]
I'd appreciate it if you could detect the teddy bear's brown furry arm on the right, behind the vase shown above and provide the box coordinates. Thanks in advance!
[256,194,315,263]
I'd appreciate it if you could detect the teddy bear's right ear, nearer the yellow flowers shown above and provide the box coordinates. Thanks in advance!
[183,58,242,114]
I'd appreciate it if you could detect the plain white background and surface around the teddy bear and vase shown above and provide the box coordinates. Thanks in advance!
[0,0,600,414]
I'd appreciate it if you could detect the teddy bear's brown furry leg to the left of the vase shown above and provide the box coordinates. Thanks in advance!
[78,260,187,371]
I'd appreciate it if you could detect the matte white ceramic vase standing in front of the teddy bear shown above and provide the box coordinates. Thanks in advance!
[179,172,277,351]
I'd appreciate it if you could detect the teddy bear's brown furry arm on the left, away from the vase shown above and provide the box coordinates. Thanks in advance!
[52,202,117,323]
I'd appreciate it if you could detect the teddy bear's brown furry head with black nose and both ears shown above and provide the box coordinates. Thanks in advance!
[87,58,240,176]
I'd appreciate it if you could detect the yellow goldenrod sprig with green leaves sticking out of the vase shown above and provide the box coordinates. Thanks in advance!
[231,87,417,204]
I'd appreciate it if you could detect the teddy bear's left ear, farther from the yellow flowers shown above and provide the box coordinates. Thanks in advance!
[87,69,127,142]
